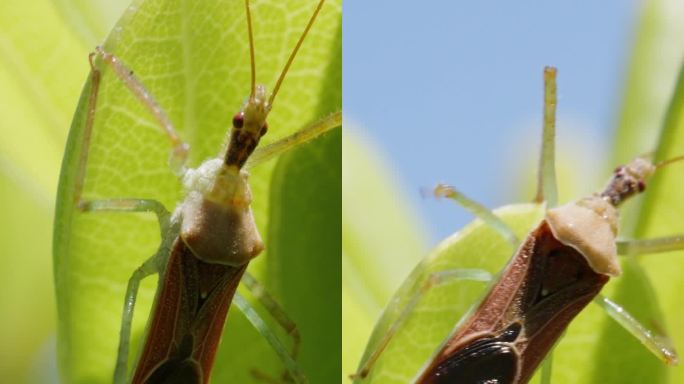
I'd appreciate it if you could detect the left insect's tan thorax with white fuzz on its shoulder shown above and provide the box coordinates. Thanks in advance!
[180,159,264,266]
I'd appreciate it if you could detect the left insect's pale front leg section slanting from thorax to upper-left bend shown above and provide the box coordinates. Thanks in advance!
[90,47,189,175]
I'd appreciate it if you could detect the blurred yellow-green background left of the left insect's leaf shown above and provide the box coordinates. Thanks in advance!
[0,0,150,383]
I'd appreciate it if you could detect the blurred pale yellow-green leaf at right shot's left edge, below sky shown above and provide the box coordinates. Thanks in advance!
[342,131,427,381]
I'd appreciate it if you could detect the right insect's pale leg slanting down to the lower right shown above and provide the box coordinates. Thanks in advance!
[594,295,679,365]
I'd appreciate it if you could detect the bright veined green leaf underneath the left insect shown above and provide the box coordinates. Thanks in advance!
[54,0,341,383]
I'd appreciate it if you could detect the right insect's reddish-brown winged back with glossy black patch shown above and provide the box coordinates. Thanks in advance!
[417,221,609,384]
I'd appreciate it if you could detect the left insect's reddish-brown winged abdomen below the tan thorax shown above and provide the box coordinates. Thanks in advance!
[132,238,247,384]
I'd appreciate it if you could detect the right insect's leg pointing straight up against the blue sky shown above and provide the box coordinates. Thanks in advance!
[534,67,558,207]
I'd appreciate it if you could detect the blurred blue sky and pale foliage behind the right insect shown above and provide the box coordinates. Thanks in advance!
[343,0,684,382]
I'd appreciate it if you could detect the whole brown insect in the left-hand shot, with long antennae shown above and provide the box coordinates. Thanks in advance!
[56,1,341,383]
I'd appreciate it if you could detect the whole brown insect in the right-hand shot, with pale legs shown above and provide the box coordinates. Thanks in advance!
[353,68,684,383]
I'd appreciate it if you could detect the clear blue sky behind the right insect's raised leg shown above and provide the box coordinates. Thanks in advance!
[343,0,640,243]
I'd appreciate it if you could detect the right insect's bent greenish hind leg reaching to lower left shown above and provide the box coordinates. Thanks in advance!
[350,269,492,380]
